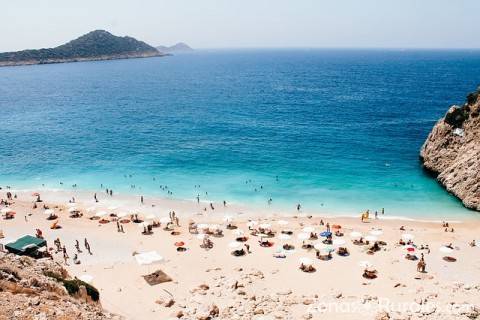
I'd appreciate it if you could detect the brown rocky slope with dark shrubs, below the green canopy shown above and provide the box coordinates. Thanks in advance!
[0,253,121,320]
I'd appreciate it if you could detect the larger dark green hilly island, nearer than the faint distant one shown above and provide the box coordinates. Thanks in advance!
[0,30,165,67]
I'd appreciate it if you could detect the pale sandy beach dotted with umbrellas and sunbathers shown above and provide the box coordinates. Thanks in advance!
[0,190,480,319]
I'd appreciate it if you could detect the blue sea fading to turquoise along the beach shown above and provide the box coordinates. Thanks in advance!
[0,49,480,217]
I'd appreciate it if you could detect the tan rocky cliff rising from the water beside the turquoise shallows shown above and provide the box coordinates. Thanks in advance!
[420,88,480,211]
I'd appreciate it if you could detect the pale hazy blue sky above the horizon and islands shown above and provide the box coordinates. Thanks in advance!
[0,0,480,51]
